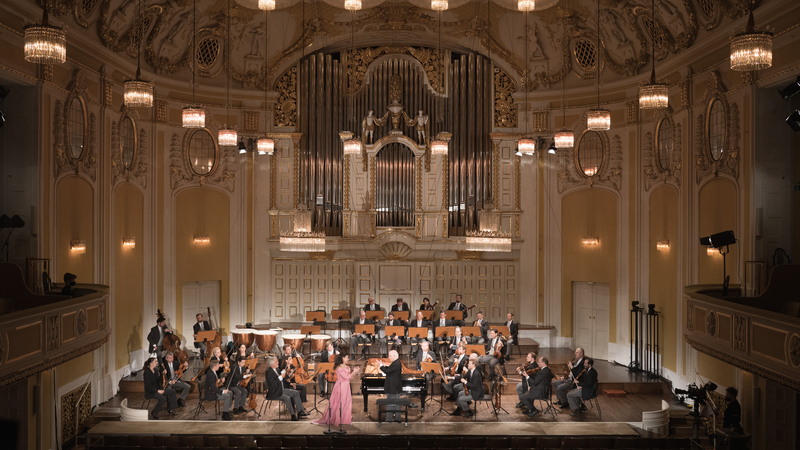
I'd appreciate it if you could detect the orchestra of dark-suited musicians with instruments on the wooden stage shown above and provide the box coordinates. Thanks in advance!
[139,295,597,421]
